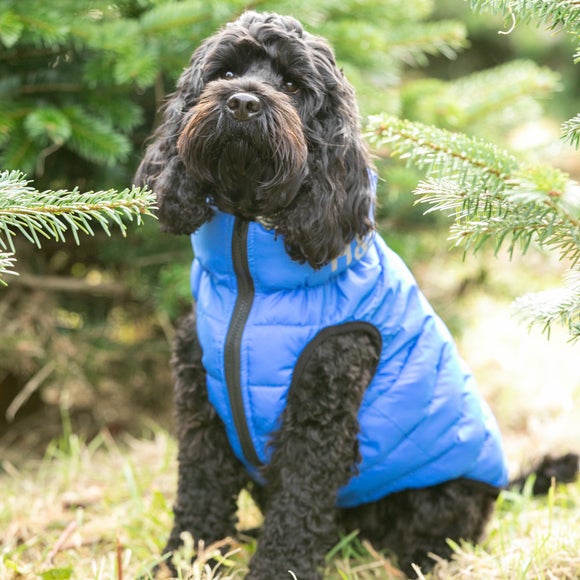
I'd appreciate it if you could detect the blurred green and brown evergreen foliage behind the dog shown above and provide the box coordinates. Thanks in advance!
[0,0,580,444]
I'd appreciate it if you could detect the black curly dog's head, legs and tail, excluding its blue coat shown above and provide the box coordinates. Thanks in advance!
[135,12,577,580]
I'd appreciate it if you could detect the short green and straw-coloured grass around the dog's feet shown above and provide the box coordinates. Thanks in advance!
[0,422,580,580]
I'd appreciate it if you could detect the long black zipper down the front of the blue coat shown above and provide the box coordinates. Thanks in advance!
[224,218,260,467]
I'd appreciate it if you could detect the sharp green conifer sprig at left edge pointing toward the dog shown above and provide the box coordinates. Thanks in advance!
[0,171,154,284]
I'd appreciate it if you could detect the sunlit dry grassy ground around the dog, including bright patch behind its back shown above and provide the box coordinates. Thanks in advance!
[0,246,580,580]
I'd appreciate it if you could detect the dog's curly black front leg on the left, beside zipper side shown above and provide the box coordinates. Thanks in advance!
[164,314,247,568]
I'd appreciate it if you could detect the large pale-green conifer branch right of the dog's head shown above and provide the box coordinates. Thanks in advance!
[368,115,580,266]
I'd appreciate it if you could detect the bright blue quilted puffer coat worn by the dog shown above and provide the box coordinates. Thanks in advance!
[191,186,507,507]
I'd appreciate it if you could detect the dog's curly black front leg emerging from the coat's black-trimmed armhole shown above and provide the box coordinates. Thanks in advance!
[248,326,379,580]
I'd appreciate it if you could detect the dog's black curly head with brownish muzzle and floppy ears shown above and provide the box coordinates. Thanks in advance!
[135,12,372,268]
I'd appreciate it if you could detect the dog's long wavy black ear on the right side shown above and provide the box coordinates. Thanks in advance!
[277,36,373,268]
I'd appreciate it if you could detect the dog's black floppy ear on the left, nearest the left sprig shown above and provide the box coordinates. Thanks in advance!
[133,41,213,234]
